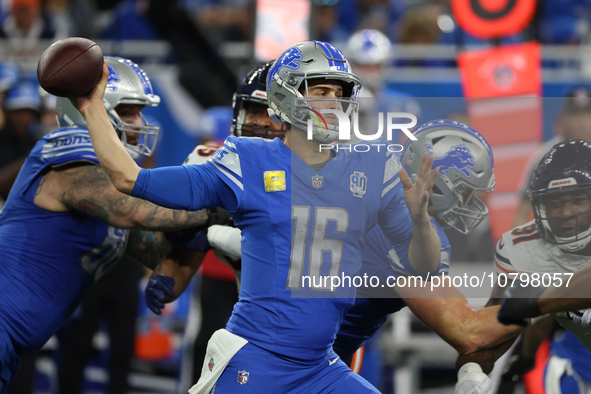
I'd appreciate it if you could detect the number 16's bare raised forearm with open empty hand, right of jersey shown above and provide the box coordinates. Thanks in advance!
[399,154,441,273]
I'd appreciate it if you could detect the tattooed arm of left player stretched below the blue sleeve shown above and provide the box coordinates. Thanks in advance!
[34,165,208,231]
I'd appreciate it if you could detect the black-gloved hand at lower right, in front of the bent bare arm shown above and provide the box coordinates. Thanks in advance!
[497,281,545,326]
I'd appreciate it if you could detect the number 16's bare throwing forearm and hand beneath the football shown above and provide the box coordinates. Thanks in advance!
[70,62,140,194]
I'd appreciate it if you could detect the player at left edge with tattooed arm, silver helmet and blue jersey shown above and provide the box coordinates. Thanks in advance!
[0,58,213,392]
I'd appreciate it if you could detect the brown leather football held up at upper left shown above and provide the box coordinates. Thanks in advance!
[37,37,104,97]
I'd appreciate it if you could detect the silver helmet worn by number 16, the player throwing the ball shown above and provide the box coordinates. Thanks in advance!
[267,41,361,143]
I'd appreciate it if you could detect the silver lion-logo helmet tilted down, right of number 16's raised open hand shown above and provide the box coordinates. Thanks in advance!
[401,119,495,234]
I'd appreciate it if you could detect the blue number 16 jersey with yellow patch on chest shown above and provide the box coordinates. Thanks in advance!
[133,137,412,360]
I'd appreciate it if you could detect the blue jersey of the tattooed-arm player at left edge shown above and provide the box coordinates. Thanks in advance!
[0,128,129,352]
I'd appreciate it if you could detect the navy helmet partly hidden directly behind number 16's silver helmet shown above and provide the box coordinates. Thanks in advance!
[231,62,285,138]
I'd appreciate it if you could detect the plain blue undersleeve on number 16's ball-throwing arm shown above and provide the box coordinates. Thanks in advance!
[131,165,237,211]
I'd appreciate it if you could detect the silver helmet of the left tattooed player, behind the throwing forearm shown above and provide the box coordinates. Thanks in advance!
[56,56,160,159]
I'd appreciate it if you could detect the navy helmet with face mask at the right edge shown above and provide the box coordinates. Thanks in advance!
[528,140,591,252]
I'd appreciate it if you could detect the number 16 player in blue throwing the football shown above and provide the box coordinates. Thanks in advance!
[73,41,440,393]
